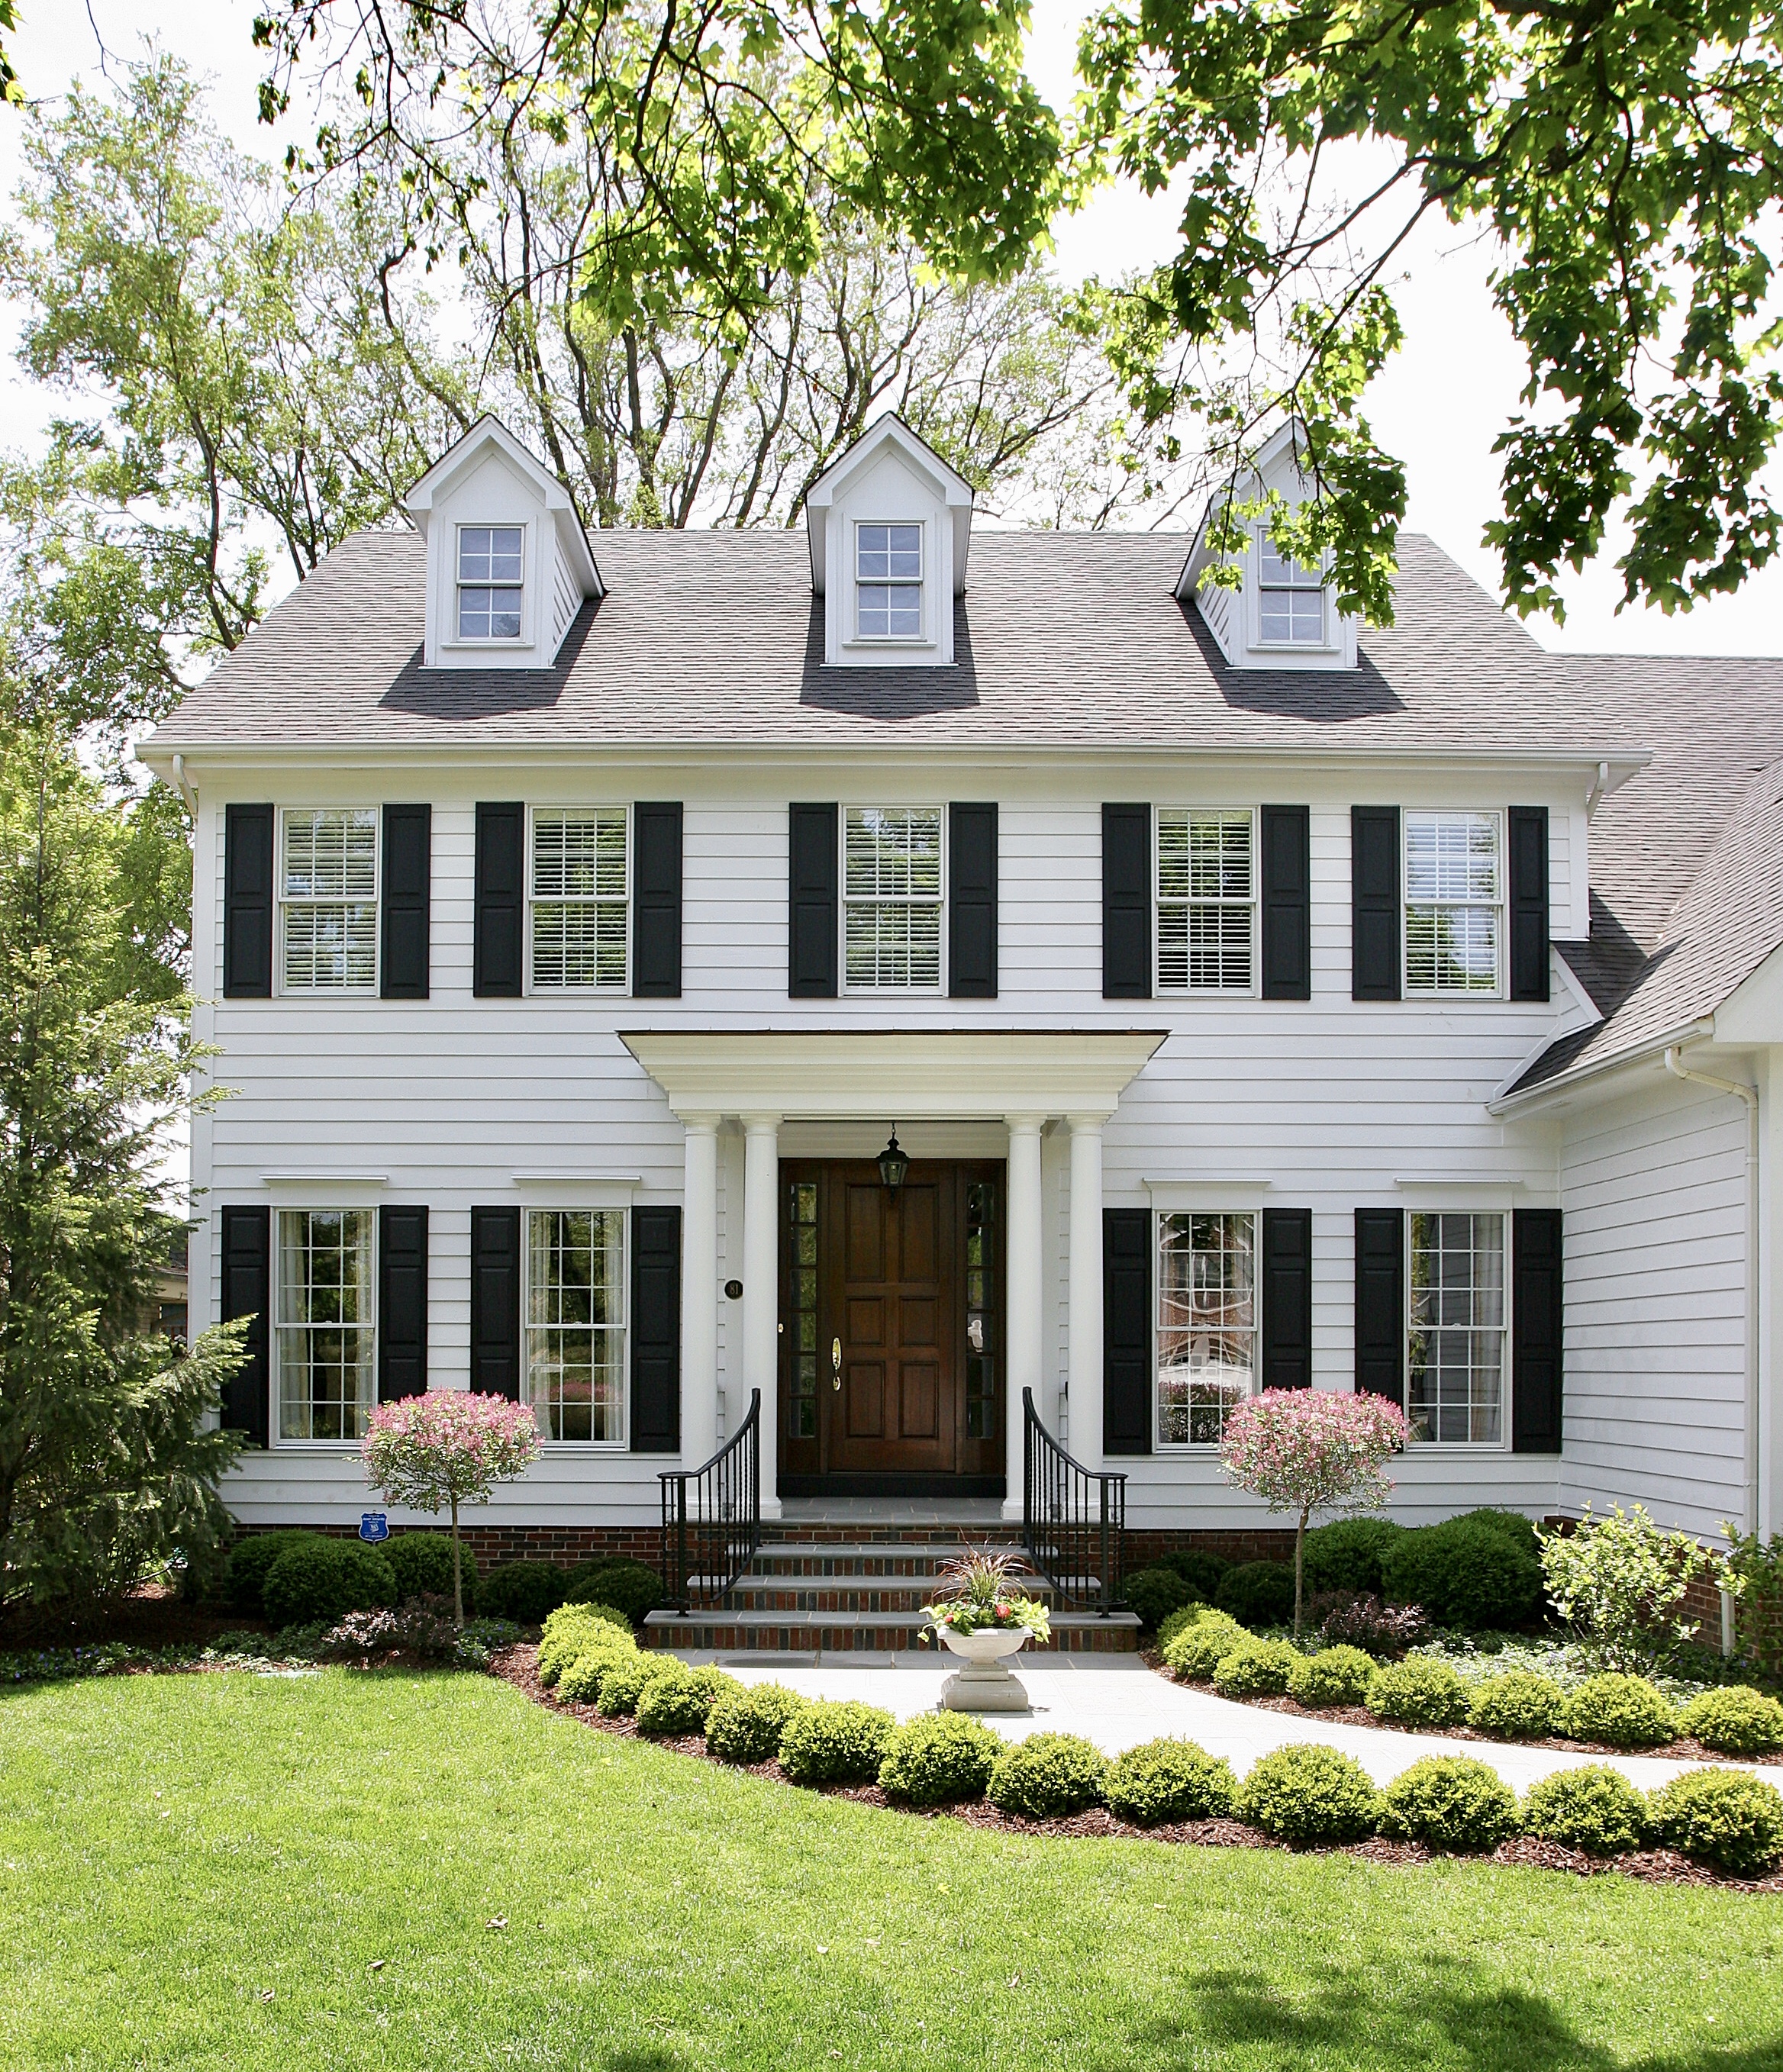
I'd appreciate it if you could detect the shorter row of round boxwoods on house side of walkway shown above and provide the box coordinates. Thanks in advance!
[1159,1608,1783,1755]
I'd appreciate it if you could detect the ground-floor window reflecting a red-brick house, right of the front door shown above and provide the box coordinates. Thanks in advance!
[1157,1214,1256,1446]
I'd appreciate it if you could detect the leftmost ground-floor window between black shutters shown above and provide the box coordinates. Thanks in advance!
[274,1208,377,1440]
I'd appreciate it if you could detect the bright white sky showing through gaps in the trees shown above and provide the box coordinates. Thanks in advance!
[0,0,1783,655]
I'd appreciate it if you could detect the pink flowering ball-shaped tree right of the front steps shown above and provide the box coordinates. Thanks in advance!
[1219,1388,1406,1639]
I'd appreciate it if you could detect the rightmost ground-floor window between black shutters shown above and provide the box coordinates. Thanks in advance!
[1406,1210,1507,1446]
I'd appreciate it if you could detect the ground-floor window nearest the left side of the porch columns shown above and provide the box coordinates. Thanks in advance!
[527,1208,626,1446]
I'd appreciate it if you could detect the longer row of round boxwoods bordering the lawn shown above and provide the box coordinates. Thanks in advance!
[539,1606,1783,1877]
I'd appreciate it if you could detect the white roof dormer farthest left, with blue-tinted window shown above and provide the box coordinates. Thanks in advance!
[406,417,603,669]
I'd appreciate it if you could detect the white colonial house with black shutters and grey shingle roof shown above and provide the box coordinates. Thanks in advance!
[141,399,1783,1616]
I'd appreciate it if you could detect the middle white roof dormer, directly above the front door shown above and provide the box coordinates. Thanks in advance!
[804,417,972,669]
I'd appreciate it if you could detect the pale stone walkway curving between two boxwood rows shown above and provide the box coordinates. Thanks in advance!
[682,1651,1783,1792]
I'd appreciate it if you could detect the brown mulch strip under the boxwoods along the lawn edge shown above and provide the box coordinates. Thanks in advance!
[492,1641,1783,1894]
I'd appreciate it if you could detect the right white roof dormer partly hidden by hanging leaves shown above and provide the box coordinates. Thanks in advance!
[1175,425,1356,669]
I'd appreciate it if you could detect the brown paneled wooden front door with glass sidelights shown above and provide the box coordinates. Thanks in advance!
[779,1160,1001,1496]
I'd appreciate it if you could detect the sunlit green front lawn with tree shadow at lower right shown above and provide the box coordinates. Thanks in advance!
[0,1670,1783,2072]
